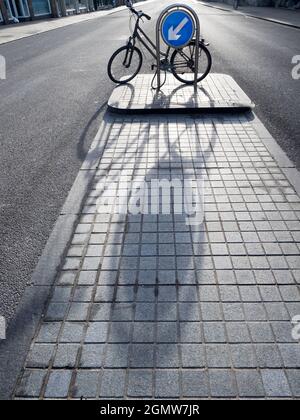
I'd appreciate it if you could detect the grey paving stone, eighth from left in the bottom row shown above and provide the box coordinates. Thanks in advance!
[209,369,238,398]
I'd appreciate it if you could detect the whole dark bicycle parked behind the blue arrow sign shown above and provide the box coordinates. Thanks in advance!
[107,0,212,85]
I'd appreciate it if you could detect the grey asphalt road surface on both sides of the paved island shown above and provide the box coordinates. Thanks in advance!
[0,0,300,319]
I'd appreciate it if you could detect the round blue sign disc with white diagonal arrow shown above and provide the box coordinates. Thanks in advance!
[161,10,195,48]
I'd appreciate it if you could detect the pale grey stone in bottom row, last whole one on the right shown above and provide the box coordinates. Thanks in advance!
[261,370,292,398]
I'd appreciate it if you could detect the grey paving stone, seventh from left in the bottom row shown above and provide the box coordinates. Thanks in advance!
[182,369,210,398]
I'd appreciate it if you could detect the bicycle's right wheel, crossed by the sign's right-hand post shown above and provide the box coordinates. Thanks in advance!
[171,41,212,85]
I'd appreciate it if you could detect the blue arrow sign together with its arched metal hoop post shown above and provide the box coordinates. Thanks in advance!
[156,4,200,90]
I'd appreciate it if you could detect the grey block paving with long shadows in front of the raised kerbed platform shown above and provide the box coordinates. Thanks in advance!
[15,116,300,398]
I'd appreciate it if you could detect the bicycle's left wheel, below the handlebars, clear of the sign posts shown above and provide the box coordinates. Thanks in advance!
[107,45,143,84]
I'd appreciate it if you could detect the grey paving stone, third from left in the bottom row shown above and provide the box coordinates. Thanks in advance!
[72,370,100,398]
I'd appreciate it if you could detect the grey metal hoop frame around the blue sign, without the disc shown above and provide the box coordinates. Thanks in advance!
[156,4,200,90]
